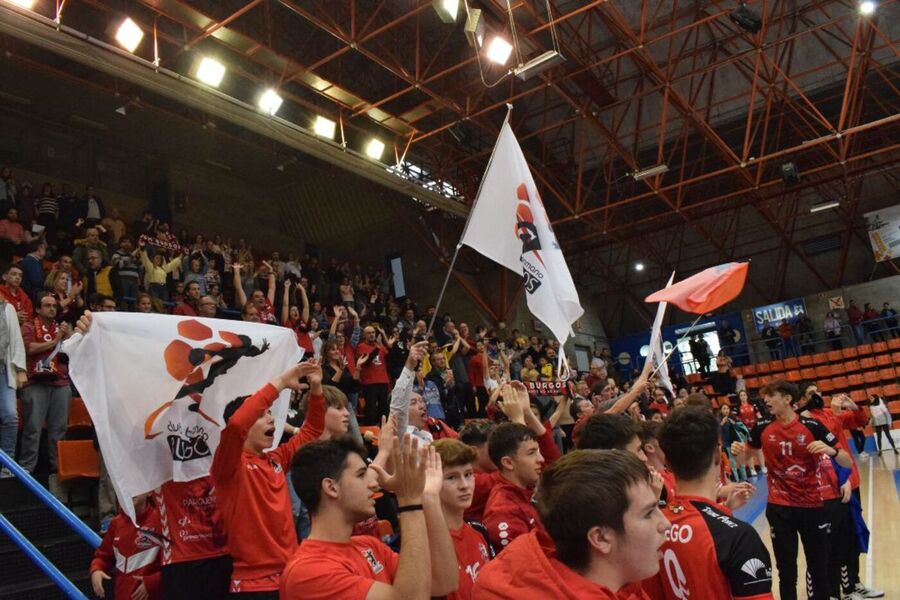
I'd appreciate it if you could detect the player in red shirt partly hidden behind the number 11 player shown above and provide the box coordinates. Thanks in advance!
[797,381,884,598]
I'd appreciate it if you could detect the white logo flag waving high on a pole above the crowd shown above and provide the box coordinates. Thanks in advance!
[460,122,584,358]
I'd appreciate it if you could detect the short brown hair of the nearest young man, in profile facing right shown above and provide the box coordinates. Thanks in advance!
[537,450,650,570]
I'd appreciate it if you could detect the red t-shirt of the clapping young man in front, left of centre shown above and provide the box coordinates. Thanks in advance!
[279,535,400,600]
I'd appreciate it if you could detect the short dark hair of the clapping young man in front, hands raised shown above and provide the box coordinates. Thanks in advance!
[291,436,366,514]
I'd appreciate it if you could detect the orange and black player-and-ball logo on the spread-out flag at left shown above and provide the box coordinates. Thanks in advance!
[144,319,269,440]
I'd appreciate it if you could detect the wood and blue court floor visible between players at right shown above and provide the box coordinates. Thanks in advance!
[736,429,900,600]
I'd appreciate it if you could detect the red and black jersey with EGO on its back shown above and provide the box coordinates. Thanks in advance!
[644,496,772,600]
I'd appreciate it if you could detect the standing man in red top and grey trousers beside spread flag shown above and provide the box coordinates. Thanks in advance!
[19,292,72,490]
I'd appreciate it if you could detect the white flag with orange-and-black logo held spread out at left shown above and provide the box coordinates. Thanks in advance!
[63,313,303,519]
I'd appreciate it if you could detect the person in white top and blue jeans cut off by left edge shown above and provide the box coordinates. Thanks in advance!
[0,298,28,478]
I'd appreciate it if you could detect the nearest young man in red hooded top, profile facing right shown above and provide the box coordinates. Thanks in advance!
[472,450,672,600]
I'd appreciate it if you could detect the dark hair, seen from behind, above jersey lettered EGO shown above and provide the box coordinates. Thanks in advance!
[657,406,720,481]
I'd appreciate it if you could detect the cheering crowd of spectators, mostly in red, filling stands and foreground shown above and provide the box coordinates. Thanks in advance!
[0,165,888,600]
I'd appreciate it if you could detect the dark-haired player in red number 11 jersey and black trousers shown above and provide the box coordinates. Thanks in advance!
[731,381,852,600]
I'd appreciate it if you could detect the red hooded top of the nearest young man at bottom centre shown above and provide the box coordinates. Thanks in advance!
[472,531,648,600]
